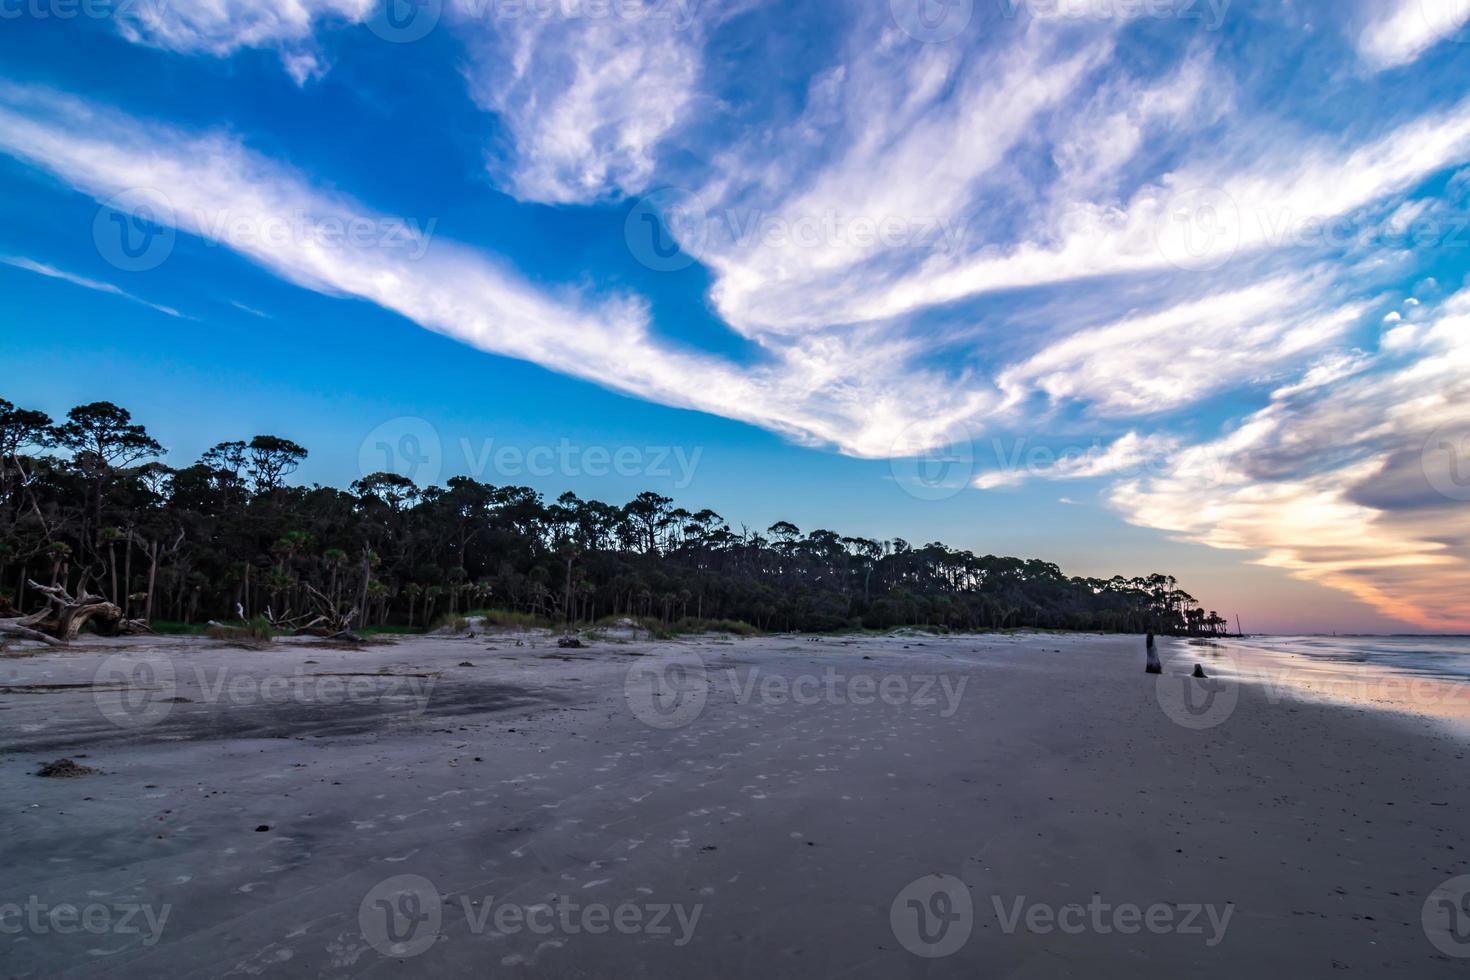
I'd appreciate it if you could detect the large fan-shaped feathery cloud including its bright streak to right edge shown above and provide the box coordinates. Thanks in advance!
[640,6,1470,336]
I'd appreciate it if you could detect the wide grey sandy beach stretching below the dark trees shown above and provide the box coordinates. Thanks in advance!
[0,633,1470,979]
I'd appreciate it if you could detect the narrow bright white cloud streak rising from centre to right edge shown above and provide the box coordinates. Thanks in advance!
[716,92,1470,329]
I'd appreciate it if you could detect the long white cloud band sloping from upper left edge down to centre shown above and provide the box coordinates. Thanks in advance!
[0,85,983,457]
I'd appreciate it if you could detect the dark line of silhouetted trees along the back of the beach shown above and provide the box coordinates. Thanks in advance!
[0,398,1226,635]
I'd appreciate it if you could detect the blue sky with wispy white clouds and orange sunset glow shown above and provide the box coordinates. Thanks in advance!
[0,0,1470,632]
